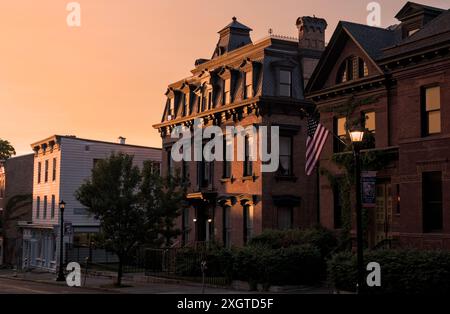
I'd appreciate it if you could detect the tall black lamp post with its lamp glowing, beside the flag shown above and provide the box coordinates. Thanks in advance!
[350,129,364,294]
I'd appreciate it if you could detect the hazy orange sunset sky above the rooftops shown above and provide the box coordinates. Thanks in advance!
[0,0,450,154]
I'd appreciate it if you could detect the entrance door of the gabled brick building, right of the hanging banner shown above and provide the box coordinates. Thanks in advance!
[375,182,392,245]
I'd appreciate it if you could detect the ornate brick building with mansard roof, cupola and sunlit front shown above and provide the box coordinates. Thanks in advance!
[155,17,327,246]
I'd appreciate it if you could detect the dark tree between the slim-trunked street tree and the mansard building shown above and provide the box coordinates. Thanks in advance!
[141,162,188,247]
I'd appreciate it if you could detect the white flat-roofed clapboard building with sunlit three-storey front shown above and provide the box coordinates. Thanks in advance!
[19,135,161,271]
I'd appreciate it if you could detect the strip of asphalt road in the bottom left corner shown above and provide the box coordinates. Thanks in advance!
[0,278,108,294]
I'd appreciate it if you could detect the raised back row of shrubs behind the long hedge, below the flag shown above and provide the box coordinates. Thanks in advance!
[250,227,337,257]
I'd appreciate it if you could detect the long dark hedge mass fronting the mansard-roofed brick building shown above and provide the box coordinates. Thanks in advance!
[172,228,337,287]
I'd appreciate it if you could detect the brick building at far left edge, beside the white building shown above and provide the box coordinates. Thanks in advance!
[0,154,34,265]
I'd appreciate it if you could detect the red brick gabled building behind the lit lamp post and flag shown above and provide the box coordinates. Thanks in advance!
[307,2,450,249]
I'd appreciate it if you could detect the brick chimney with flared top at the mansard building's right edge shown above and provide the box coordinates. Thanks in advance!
[297,16,328,86]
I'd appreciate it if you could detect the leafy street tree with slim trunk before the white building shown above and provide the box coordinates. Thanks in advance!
[76,153,144,286]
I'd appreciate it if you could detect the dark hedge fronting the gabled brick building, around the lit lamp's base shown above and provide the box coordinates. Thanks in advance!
[328,250,450,294]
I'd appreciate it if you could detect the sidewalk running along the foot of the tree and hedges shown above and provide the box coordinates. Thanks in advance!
[0,270,330,294]
